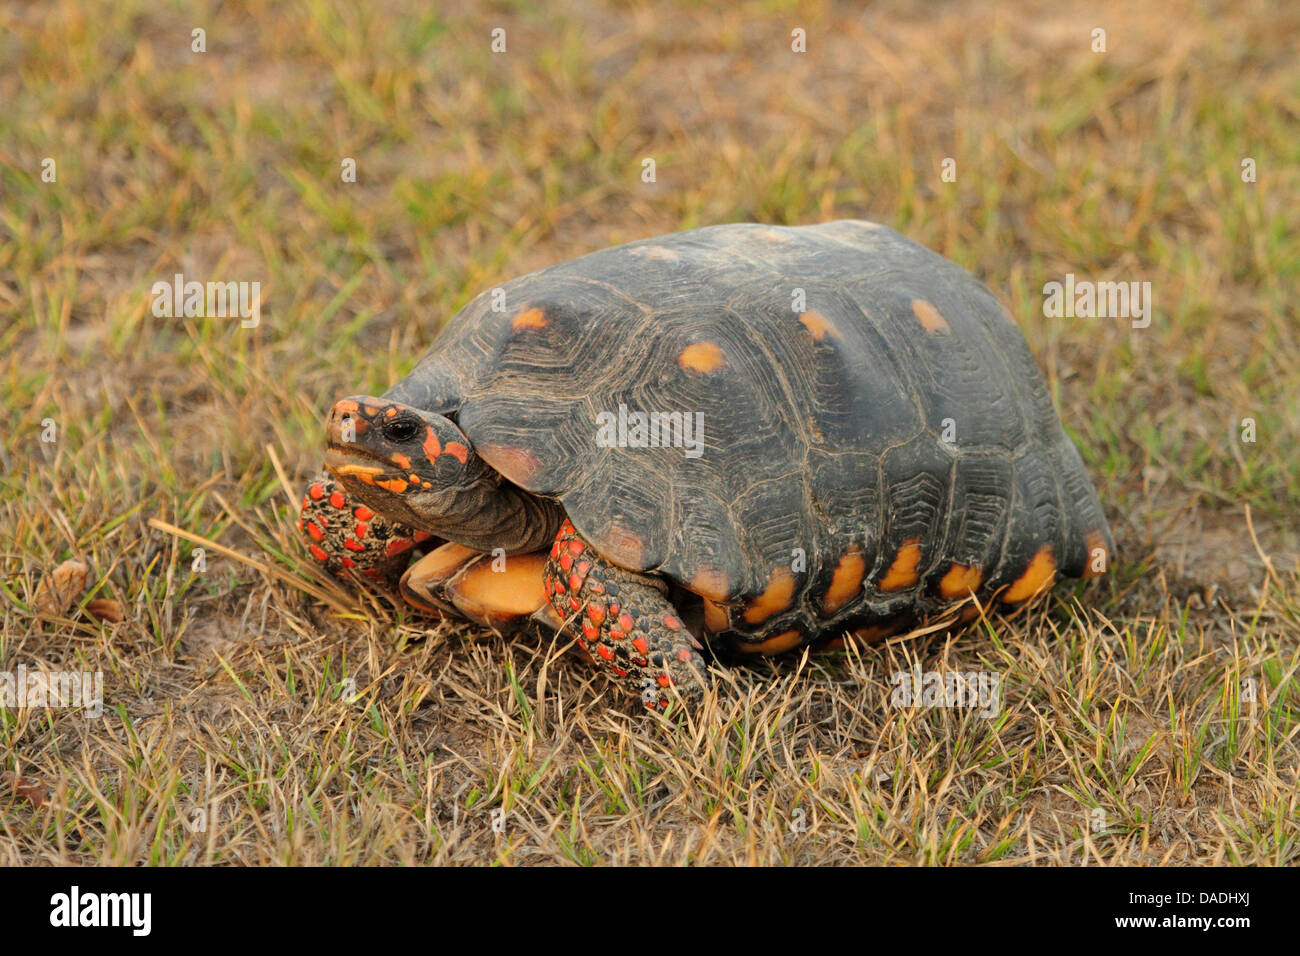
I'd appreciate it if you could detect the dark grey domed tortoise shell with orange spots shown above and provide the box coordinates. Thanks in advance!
[385,221,1113,643]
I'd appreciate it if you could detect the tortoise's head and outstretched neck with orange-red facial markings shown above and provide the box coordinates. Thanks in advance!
[325,395,560,553]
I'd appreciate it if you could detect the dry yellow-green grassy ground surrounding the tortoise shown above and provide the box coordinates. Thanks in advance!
[0,0,1300,865]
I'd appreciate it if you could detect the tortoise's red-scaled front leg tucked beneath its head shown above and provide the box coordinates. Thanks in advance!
[298,472,430,587]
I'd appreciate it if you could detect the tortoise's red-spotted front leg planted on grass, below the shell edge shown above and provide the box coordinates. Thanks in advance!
[545,519,709,710]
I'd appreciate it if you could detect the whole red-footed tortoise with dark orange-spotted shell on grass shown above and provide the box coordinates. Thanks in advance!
[300,220,1114,710]
